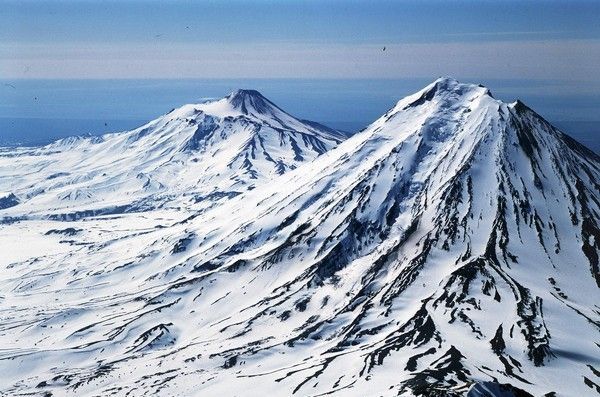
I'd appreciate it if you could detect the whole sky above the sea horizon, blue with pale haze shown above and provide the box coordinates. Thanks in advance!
[0,0,600,81]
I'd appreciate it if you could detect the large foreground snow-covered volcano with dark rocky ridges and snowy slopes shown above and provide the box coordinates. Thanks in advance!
[0,78,600,396]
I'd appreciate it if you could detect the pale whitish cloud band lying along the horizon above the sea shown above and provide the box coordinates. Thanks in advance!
[0,39,600,83]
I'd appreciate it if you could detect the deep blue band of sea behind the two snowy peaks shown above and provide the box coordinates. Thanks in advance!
[0,78,600,153]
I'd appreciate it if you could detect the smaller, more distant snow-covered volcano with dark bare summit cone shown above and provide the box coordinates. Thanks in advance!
[0,90,345,219]
